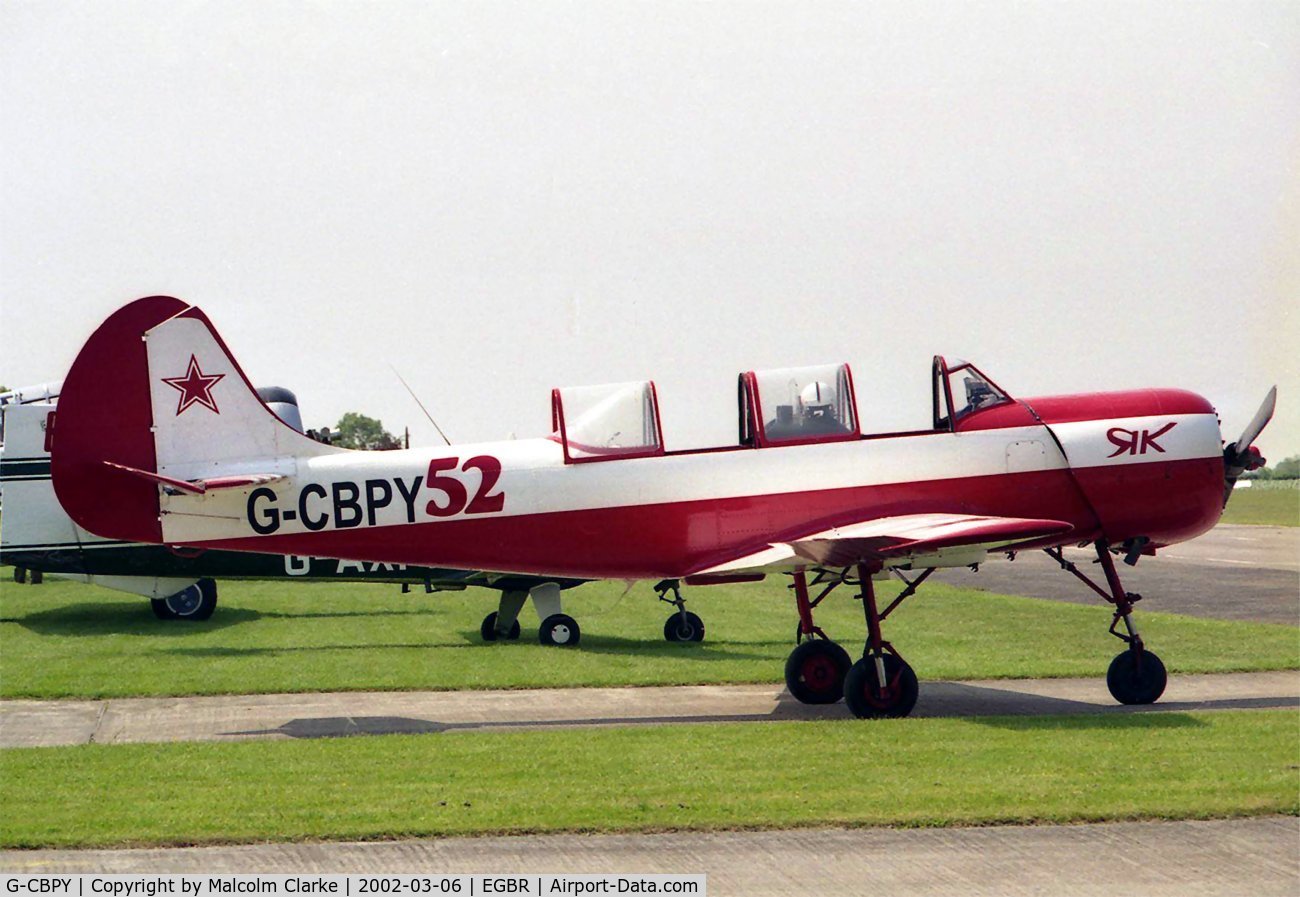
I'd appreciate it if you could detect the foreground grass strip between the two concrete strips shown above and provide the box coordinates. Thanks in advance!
[0,711,1300,848]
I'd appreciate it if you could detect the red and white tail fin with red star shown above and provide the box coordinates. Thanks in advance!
[51,296,341,542]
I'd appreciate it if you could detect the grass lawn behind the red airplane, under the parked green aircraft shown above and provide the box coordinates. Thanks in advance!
[0,571,1300,697]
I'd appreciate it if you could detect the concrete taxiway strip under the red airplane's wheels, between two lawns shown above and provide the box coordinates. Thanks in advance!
[0,671,1300,748]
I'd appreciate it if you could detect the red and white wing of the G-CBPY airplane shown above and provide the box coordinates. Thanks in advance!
[692,514,1073,576]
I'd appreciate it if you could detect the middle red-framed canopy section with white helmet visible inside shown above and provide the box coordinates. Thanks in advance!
[740,364,862,447]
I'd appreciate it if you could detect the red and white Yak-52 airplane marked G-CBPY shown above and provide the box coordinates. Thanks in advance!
[52,296,1275,716]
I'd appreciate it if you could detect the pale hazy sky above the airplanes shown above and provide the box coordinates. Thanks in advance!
[0,0,1300,462]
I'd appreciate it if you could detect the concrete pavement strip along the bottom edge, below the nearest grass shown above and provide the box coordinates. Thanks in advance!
[0,816,1300,897]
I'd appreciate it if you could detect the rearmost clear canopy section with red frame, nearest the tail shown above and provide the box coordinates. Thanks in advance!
[551,380,663,463]
